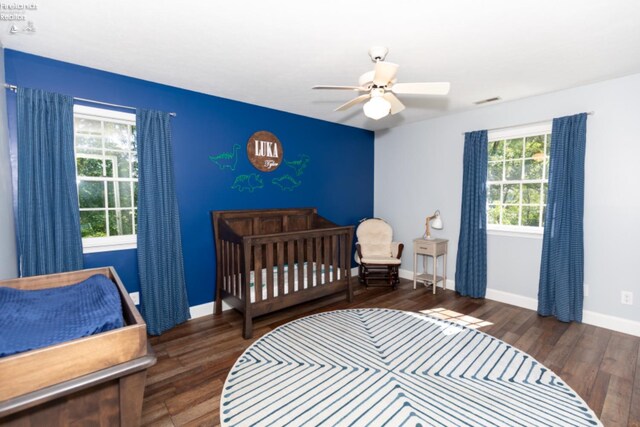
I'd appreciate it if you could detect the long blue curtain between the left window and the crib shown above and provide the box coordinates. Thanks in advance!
[136,110,190,335]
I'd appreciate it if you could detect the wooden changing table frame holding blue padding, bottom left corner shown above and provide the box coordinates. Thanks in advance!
[0,267,156,426]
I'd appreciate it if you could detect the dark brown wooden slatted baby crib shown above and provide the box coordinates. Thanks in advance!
[211,208,353,339]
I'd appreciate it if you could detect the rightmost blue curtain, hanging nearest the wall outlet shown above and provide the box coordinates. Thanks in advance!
[538,113,587,322]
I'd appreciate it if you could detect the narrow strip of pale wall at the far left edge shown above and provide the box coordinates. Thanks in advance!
[0,45,18,279]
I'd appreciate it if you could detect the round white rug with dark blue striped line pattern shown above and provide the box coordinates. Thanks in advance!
[220,309,602,427]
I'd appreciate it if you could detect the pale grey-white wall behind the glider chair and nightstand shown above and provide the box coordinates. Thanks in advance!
[374,74,640,321]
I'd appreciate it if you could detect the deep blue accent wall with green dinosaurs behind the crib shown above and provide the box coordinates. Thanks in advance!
[5,49,374,306]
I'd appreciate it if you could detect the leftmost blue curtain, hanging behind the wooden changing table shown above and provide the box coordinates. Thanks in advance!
[17,88,82,276]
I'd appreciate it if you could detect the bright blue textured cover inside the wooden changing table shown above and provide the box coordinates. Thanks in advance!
[0,274,124,357]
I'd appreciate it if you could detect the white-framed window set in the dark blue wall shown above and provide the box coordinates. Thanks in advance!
[74,105,138,253]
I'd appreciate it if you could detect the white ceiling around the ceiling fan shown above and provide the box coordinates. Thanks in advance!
[0,0,640,130]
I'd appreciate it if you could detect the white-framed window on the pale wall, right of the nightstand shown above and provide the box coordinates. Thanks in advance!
[487,123,551,234]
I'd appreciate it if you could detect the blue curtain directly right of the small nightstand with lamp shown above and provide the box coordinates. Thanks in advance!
[456,130,489,298]
